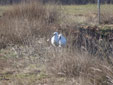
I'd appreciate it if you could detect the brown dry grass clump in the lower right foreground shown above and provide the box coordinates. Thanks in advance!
[48,49,113,85]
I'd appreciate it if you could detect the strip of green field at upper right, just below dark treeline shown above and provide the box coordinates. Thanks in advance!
[62,4,113,14]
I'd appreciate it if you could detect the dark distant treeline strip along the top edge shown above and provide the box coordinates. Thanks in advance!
[0,0,113,4]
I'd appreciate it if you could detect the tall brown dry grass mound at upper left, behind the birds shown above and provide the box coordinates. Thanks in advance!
[0,2,60,44]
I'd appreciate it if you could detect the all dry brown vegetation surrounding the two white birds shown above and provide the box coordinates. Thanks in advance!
[0,2,113,85]
